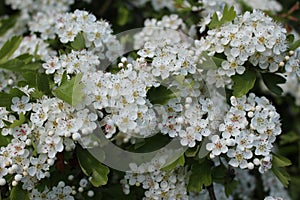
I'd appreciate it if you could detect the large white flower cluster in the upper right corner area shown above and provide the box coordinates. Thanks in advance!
[195,10,287,85]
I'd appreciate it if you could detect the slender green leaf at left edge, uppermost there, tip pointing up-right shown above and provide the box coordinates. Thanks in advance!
[0,36,23,63]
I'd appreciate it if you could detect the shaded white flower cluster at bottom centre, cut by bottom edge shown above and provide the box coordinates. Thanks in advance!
[121,157,188,200]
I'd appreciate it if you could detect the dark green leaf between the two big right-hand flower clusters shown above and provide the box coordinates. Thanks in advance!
[231,70,256,97]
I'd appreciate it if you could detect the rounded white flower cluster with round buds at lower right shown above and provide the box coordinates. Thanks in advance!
[206,93,281,173]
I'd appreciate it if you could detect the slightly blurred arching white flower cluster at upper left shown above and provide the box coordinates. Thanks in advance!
[29,10,122,61]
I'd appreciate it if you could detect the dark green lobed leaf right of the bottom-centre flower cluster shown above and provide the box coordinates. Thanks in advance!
[187,160,212,192]
